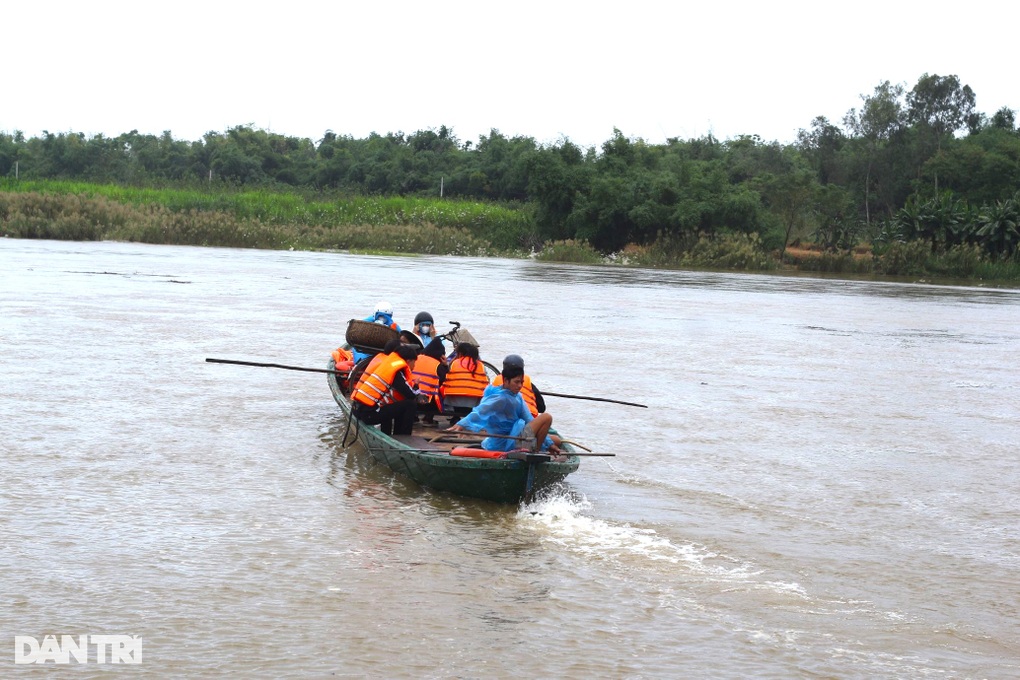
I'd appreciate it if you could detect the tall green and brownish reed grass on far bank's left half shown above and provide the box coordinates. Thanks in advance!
[0,180,533,255]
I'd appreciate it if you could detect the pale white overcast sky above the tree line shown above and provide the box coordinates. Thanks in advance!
[0,0,1020,147]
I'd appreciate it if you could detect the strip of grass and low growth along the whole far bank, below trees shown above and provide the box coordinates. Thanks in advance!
[0,178,1020,282]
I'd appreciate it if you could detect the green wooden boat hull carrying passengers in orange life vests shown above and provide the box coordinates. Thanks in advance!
[327,321,580,504]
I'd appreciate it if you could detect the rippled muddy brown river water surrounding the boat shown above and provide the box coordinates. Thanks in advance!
[0,239,1020,678]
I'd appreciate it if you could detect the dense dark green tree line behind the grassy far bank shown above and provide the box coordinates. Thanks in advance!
[0,73,1020,259]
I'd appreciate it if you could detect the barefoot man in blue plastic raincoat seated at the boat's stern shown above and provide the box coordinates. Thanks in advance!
[447,366,562,456]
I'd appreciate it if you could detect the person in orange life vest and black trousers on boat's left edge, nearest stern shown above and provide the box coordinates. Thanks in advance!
[351,343,418,434]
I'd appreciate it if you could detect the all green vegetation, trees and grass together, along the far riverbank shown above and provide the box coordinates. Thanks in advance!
[0,80,1020,285]
